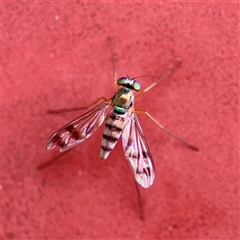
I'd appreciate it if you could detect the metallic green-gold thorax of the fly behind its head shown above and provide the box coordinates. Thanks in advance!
[113,88,134,114]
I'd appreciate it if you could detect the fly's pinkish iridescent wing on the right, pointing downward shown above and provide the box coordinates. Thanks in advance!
[122,112,155,188]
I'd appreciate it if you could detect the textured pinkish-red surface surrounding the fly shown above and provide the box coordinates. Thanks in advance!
[1,2,239,239]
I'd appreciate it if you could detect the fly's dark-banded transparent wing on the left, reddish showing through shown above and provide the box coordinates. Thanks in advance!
[46,101,111,152]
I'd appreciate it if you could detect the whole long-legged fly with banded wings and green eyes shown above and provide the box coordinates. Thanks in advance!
[38,38,198,220]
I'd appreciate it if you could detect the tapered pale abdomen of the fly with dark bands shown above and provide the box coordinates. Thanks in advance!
[100,111,126,159]
